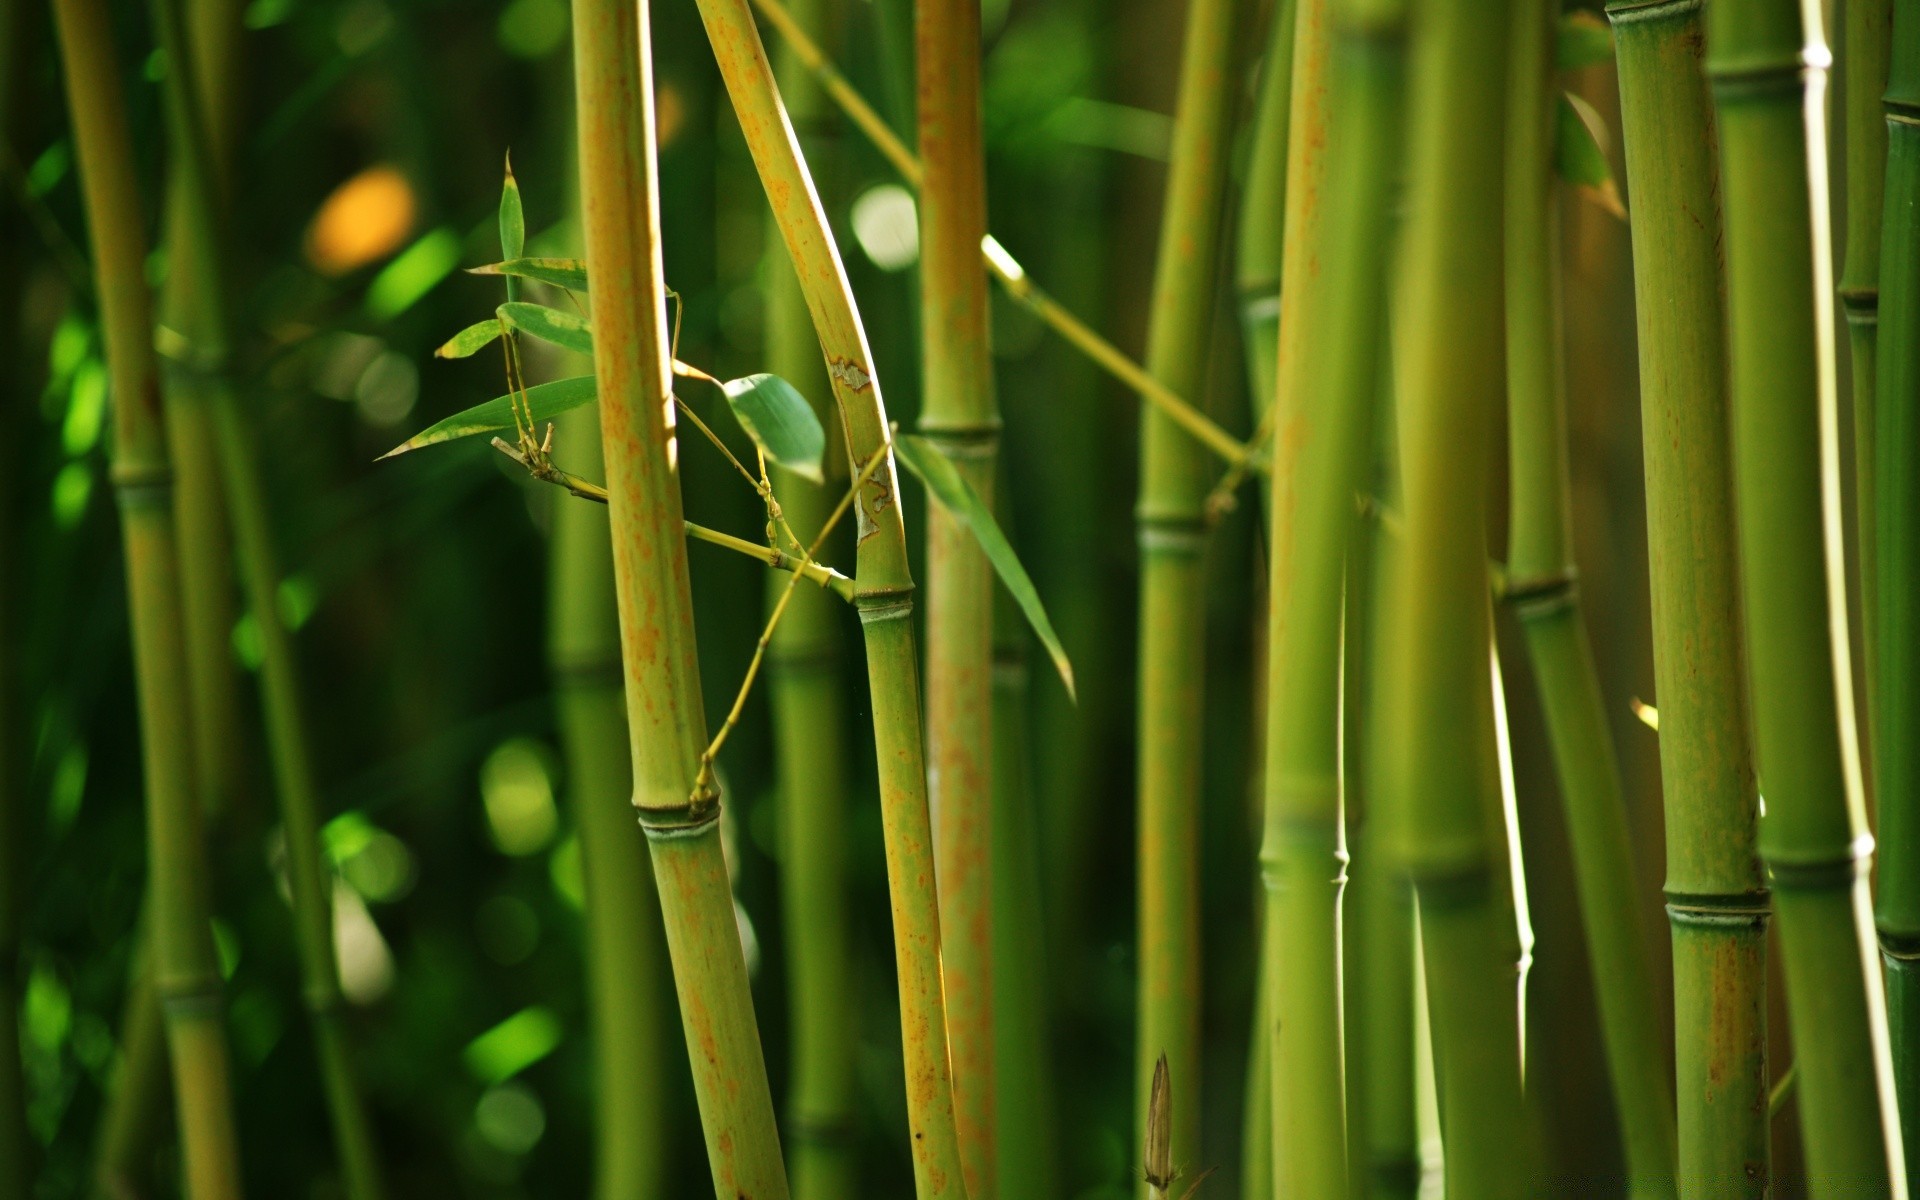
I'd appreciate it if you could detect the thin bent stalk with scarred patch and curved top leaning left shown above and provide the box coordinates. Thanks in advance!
[683,0,964,1200]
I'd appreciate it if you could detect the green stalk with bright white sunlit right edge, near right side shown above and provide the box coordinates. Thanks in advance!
[1707,0,1907,1196]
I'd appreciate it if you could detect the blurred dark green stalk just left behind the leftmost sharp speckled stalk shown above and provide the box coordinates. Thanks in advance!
[547,409,676,1200]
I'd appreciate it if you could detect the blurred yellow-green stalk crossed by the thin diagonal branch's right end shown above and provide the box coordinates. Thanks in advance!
[1133,0,1236,1196]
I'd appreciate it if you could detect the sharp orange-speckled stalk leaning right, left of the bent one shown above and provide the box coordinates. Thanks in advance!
[572,0,787,1200]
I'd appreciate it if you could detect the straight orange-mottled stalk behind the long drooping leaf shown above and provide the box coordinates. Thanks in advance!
[914,0,1000,1200]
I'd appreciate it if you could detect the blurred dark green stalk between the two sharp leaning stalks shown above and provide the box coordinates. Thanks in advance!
[764,0,858,1200]
